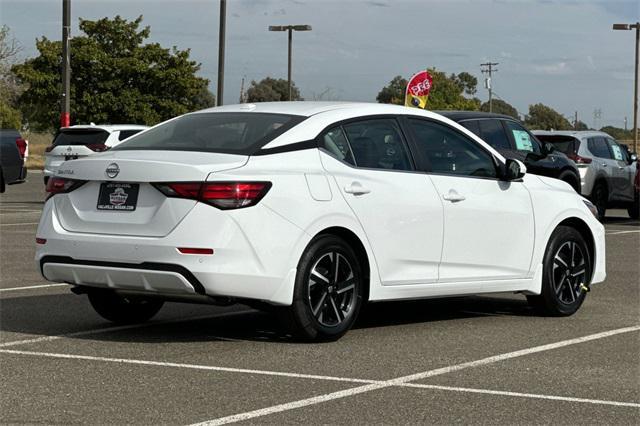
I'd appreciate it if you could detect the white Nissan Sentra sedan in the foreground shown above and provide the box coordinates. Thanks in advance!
[36,102,605,340]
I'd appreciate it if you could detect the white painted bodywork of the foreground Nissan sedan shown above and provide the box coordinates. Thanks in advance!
[35,102,606,305]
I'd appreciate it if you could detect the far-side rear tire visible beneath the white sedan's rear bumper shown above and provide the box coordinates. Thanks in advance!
[88,289,164,324]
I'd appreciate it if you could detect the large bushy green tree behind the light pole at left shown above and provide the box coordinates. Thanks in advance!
[13,16,212,130]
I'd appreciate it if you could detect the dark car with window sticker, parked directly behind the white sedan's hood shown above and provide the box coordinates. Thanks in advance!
[437,111,580,193]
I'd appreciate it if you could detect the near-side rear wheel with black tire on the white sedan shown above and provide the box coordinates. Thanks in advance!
[281,235,365,341]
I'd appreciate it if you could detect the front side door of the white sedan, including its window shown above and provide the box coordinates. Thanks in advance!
[407,118,534,282]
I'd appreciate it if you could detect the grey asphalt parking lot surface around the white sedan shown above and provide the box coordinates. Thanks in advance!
[0,174,640,424]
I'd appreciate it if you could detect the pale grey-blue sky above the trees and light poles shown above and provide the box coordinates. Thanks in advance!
[0,0,640,128]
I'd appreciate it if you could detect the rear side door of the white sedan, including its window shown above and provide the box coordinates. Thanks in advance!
[319,118,443,286]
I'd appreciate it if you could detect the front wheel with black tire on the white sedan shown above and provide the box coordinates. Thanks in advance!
[527,226,592,316]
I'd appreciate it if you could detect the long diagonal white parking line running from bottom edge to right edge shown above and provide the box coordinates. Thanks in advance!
[192,325,640,426]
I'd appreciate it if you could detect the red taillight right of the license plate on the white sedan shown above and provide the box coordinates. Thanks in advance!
[154,182,271,210]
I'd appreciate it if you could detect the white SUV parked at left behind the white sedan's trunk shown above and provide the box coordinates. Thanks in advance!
[44,124,148,185]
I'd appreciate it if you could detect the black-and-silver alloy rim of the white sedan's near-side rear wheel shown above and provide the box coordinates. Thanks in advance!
[308,251,358,327]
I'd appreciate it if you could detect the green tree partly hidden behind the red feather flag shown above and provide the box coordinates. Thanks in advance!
[376,68,480,111]
